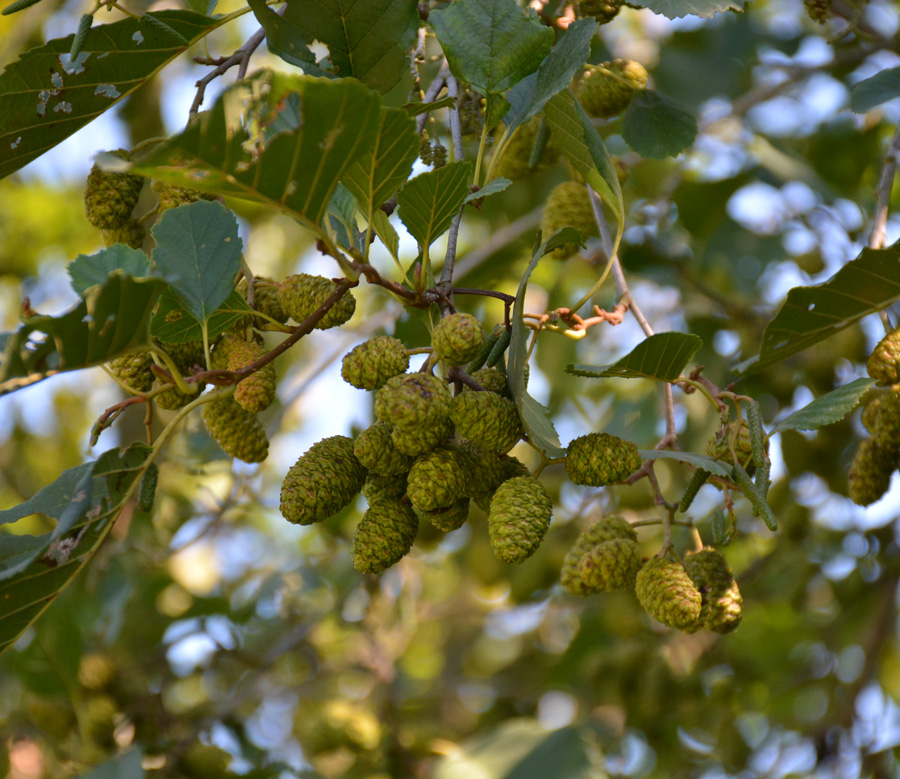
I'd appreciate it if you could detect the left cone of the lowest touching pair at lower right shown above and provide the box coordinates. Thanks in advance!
[635,557,703,633]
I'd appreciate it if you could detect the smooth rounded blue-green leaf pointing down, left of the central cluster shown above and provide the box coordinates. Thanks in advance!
[153,200,243,322]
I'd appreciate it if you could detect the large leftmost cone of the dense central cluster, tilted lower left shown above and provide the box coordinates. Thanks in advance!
[281,435,366,525]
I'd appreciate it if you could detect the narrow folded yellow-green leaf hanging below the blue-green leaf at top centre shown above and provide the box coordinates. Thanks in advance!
[544,90,625,225]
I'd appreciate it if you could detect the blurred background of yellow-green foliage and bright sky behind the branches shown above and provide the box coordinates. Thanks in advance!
[0,0,900,779]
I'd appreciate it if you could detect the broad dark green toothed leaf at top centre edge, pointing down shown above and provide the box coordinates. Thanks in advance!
[428,0,553,95]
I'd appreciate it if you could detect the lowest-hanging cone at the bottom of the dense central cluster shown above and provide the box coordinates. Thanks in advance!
[350,500,419,573]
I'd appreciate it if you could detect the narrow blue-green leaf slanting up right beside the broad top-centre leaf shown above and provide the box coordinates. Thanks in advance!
[506,19,599,132]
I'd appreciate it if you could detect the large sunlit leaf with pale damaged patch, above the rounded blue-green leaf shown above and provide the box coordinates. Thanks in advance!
[134,71,381,236]
